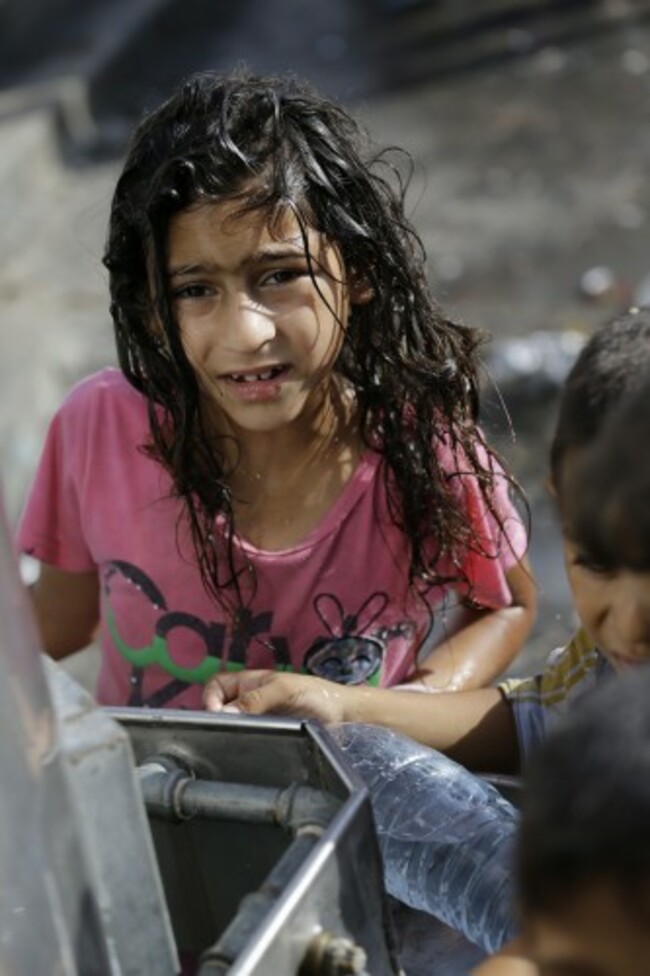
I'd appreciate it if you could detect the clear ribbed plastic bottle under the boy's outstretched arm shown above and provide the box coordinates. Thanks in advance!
[334,723,518,953]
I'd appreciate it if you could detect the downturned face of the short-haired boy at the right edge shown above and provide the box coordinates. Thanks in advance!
[563,463,650,671]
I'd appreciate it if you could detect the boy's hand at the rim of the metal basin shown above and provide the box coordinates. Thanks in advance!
[203,671,351,722]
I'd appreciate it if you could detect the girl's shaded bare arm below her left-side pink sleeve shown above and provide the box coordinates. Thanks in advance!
[30,563,99,661]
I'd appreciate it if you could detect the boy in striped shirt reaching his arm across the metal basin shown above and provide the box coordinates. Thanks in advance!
[207,309,650,772]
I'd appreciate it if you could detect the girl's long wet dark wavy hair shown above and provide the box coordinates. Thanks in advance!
[104,71,516,599]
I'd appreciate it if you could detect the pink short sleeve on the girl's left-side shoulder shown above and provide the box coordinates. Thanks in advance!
[16,404,95,572]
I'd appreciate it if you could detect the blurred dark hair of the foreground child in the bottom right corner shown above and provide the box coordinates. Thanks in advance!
[518,666,650,920]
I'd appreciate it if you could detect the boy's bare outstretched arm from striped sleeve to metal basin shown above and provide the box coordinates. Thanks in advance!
[204,671,519,773]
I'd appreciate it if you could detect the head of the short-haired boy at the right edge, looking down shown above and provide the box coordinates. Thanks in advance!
[551,310,650,670]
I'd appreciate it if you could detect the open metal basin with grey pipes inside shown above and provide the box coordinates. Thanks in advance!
[107,709,399,976]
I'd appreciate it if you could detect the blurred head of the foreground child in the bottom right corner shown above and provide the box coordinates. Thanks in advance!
[518,668,650,976]
